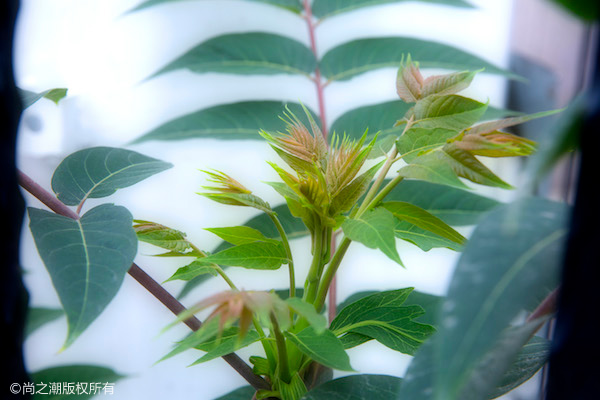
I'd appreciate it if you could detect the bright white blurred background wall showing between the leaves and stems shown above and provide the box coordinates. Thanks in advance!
[15,0,512,400]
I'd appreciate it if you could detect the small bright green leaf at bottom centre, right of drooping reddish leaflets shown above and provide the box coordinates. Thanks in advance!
[283,326,353,371]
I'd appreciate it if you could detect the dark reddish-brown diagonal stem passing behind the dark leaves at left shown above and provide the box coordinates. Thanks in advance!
[18,171,271,390]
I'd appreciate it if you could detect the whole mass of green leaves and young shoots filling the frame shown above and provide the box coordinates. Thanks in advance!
[18,0,568,400]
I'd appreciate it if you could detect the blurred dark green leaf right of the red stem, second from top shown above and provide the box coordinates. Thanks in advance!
[319,37,515,81]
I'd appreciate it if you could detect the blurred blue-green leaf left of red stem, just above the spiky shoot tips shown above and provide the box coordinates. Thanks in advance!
[134,101,314,143]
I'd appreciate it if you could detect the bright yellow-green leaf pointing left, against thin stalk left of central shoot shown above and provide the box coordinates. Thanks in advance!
[195,242,289,269]
